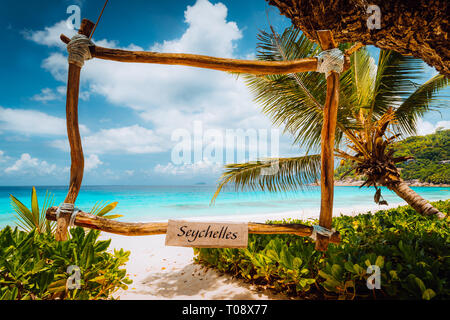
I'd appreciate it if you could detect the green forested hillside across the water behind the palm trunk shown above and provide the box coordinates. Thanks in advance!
[335,130,450,187]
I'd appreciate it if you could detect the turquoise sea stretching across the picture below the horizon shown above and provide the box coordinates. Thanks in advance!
[0,185,450,227]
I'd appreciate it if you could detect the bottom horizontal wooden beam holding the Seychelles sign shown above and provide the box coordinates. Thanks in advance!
[46,207,340,243]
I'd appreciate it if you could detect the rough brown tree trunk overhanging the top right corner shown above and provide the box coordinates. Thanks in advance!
[266,0,450,76]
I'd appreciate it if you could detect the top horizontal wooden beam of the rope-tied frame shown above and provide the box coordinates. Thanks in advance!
[60,35,317,75]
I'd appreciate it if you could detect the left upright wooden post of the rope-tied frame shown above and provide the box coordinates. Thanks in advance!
[55,19,94,241]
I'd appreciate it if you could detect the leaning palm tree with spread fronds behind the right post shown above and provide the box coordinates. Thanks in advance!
[213,27,448,218]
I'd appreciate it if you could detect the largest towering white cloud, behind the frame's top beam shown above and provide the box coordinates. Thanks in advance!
[38,0,271,153]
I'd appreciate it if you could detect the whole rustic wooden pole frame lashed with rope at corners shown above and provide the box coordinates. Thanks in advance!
[51,19,342,251]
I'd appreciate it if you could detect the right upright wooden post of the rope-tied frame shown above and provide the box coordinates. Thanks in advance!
[316,30,339,251]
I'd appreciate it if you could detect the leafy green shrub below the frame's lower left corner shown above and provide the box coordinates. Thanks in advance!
[0,226,131,300]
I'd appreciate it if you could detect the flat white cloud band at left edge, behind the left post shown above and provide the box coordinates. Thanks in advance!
[0,107,89,135]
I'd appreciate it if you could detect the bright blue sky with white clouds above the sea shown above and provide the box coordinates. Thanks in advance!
[0,0,450,185]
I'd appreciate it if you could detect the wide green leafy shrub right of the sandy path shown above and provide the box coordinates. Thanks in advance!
[195,200,450,299]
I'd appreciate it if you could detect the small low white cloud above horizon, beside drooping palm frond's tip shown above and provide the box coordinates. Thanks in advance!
[153,159,223,176]
